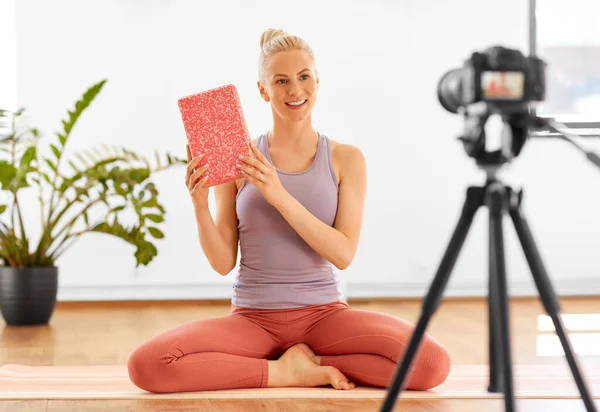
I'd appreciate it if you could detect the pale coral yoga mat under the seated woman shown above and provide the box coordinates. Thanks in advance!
[0,363,600,400]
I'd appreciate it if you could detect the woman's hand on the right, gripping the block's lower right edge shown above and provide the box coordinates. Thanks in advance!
[237,144,287,206]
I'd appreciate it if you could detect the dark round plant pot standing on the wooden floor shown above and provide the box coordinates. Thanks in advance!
[0,266,58,325]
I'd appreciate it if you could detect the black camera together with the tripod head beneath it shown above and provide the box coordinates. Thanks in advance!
[437,46,546,165]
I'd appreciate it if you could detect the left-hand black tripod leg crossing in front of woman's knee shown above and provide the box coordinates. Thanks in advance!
[381,187,484,412]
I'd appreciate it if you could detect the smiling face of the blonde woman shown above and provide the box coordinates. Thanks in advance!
[258,50,319,121]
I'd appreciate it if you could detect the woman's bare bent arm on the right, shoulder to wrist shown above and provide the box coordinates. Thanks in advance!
[273,144,367,270]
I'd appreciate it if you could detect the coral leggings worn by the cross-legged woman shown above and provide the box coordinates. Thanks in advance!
[127,301,450,393]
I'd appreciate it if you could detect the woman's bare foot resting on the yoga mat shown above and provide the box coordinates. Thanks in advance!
[277,343,356,390]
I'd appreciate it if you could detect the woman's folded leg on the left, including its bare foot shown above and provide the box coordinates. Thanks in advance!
[127,314,354,393]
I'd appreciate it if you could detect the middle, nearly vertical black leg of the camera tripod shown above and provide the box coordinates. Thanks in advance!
[487,185,515,412]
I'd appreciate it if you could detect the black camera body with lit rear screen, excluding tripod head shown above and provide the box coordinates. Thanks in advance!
[437,46,546,113]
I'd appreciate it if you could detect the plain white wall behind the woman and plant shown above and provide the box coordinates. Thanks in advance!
[8,0,600,300]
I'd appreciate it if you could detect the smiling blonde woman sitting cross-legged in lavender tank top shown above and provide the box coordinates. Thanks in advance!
[128,29,450,392]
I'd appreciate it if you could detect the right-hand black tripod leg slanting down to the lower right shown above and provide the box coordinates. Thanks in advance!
[510,194,596,412]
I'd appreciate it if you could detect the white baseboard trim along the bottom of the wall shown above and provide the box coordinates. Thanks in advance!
[57,277,600,301]
